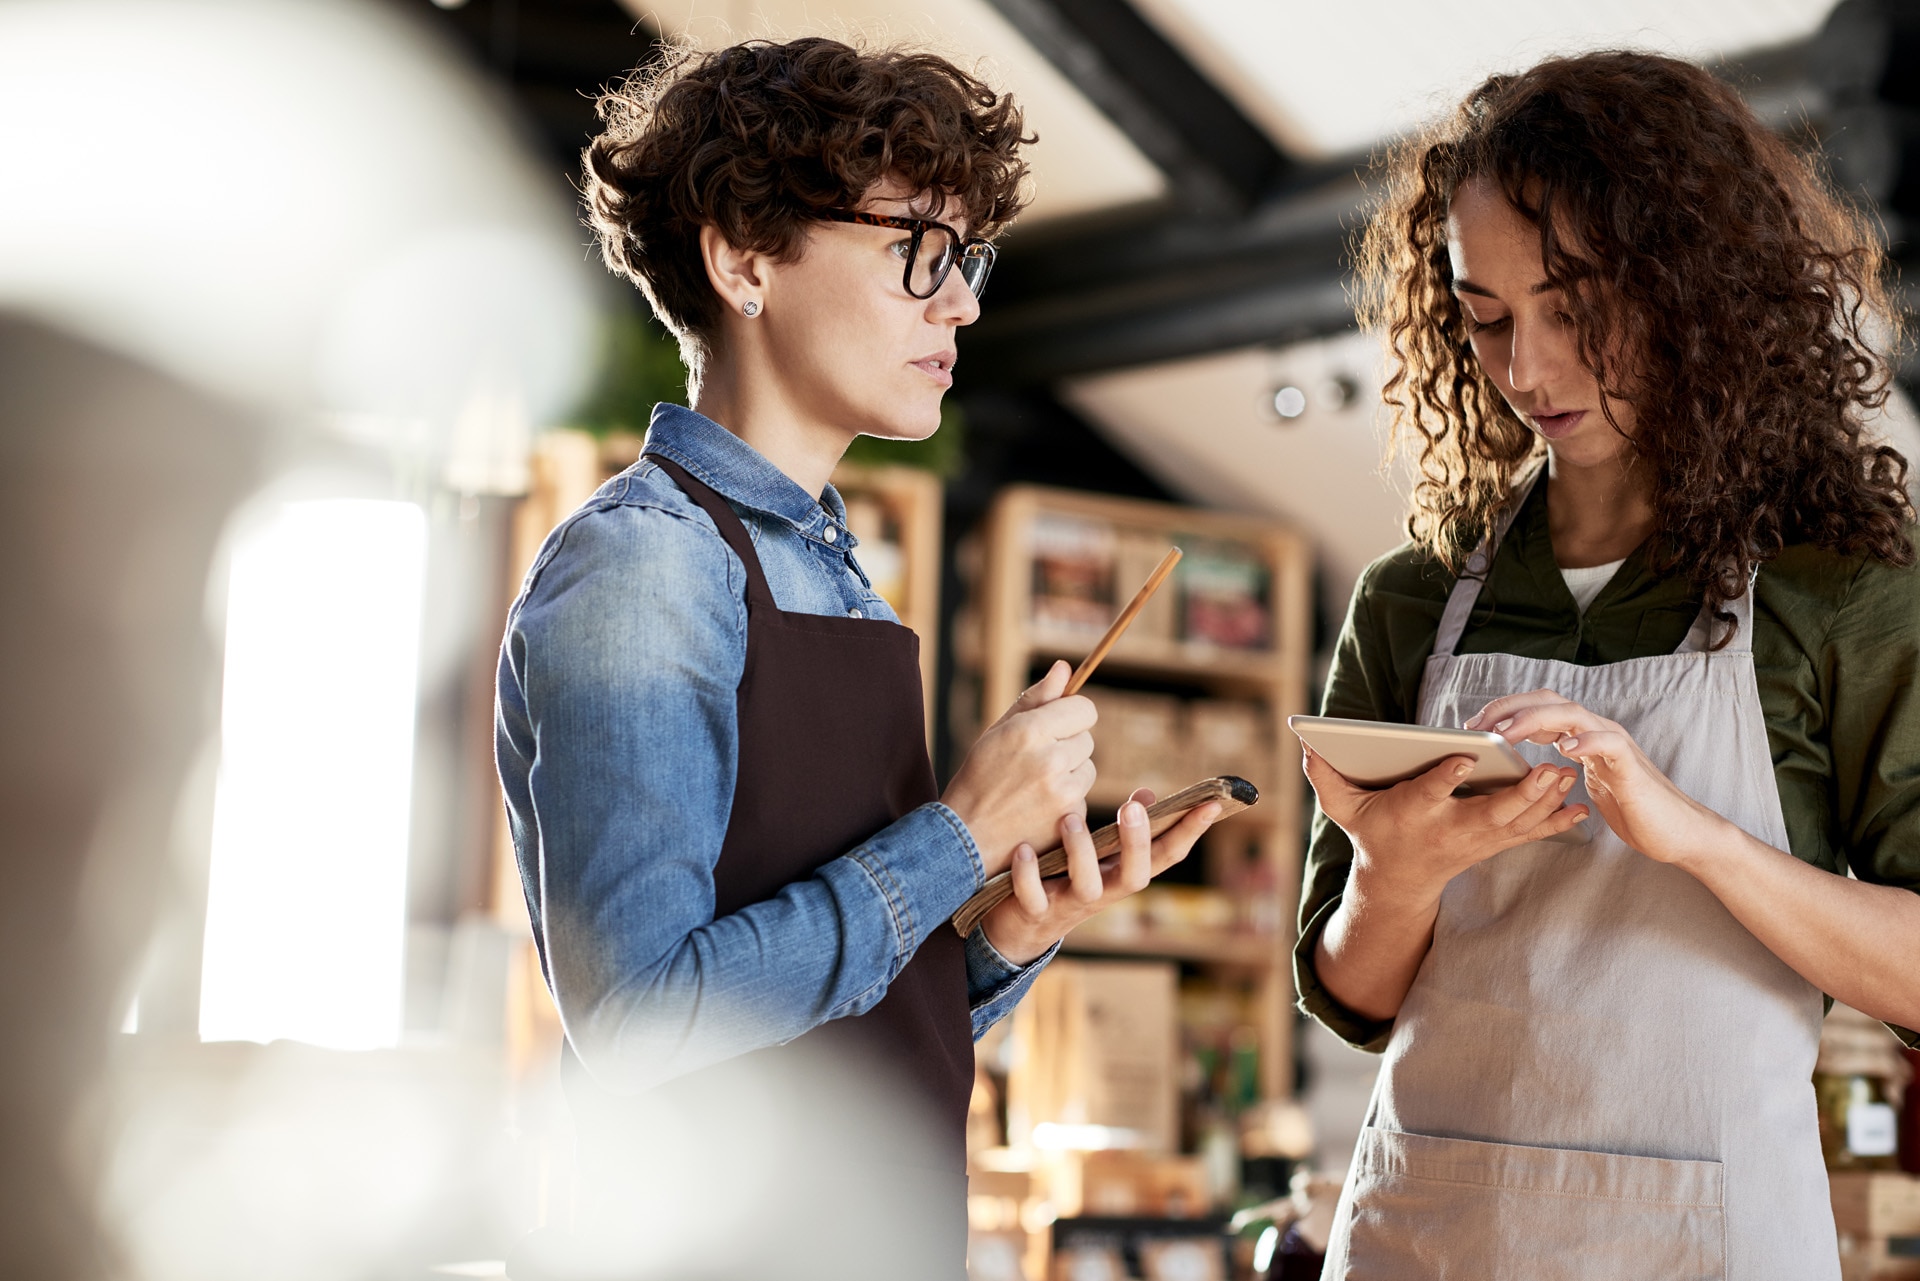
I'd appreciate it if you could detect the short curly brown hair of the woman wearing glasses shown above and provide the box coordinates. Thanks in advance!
[584,36,1035,378]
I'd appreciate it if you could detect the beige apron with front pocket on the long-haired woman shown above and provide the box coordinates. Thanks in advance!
[1325,476,1839,1281]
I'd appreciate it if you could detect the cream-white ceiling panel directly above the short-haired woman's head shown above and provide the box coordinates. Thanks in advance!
[622,0,1165,225]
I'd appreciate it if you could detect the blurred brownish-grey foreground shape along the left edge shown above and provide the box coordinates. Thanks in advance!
[0,315,257,1281]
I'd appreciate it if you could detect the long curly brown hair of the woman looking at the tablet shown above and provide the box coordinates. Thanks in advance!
[1357,52,1914,633]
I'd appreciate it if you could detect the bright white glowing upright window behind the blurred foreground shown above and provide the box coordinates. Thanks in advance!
[200,499,426,1051]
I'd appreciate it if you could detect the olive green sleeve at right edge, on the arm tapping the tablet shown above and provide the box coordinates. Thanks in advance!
[1818,561,1920,1047]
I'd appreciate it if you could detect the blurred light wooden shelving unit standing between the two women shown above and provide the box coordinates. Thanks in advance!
[967,486,1313,1099]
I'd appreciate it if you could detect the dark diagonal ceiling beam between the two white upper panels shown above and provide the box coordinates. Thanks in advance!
[989,0,1288,215]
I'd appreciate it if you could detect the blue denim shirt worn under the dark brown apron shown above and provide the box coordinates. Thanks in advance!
[493,403,1052,1091]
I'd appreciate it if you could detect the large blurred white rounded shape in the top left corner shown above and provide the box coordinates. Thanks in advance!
[0,0,597,485]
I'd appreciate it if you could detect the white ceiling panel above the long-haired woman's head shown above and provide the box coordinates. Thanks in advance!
[1133,0,1834,157]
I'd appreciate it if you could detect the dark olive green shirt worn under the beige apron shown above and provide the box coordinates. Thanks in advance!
[1294,484,1920,1051]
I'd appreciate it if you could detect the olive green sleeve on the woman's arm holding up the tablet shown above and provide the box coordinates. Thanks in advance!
[1294,565,1411,1052]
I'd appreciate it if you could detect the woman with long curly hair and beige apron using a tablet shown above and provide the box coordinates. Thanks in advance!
[1294,52,1920,1281]
